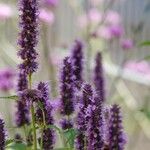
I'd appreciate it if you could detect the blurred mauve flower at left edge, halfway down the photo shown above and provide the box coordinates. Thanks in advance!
[0,68,15,92]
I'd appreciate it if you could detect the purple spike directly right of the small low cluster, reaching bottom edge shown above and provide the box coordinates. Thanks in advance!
[75,84,93,150]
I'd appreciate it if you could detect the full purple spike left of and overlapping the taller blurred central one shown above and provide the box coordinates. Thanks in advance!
[60,57,74,116]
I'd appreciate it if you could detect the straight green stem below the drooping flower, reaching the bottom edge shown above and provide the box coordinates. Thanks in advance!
[31,103,37,150]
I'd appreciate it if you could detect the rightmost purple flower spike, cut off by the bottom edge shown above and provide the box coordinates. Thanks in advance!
[109,104,126,150]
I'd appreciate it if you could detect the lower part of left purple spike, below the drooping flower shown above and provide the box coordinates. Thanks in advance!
[15,99,30,127]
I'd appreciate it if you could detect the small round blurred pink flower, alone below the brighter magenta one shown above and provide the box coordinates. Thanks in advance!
[121,39,134,50]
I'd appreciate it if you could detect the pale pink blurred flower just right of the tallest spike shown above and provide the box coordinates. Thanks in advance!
[39,9,55,24]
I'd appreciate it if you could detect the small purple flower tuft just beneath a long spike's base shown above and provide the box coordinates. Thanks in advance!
[60,119,73,130]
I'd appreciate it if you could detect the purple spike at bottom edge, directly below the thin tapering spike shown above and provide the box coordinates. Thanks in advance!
[87,105,104,150]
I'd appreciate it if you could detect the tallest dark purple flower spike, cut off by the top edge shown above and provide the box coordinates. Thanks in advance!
[18,0,38,74]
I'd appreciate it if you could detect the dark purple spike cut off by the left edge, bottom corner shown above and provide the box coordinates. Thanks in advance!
[0,119,5,150]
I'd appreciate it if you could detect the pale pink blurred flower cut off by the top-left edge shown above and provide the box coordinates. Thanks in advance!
[0,4,13,19]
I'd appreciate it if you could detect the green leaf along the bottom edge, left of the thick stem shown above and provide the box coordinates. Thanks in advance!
[6,142,27,150]
